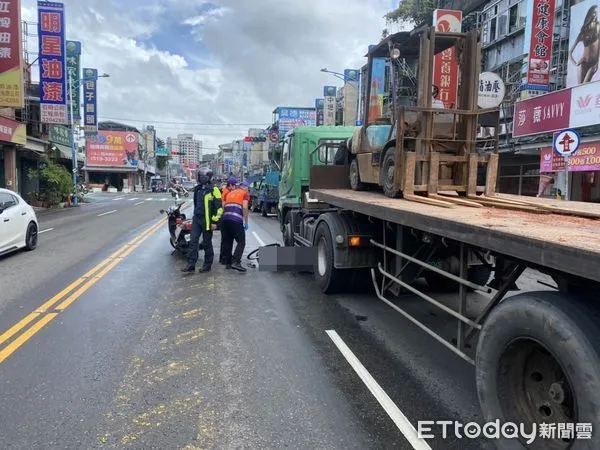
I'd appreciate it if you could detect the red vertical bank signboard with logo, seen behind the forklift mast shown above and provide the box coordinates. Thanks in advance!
[433,9,462,108]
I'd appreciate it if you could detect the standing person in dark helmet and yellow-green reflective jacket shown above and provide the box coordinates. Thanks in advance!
[182,169,223,273]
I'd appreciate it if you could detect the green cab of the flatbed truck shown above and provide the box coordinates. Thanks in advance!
[278,126,355,239]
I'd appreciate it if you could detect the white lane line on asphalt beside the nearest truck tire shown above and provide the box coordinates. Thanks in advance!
[326,330,431,450]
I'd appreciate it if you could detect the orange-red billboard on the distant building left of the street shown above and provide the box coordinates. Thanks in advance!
[86,131,139,168]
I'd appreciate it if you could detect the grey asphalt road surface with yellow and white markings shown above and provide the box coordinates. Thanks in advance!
[0,194,536,449]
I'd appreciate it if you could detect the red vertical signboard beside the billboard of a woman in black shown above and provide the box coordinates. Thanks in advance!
[527,0,556,88]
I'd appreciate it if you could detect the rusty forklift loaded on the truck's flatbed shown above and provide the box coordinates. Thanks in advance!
[347,27,500,207]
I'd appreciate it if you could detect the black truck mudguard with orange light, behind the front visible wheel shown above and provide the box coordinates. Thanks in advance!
[310,212,377,269]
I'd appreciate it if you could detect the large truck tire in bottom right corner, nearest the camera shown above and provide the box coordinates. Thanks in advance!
[476,292,600,450]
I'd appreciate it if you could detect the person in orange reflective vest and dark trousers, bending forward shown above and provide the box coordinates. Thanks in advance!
[221,181,250,272]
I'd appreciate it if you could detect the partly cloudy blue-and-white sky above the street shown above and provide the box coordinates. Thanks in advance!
[22,0,397,153]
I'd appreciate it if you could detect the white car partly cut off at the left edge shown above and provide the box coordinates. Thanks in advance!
[0,189,38,255]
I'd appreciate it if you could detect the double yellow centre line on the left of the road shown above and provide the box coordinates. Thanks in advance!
[0,213,173,363]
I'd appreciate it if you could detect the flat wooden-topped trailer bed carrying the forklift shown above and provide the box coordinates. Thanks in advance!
[310,189,600,282]
